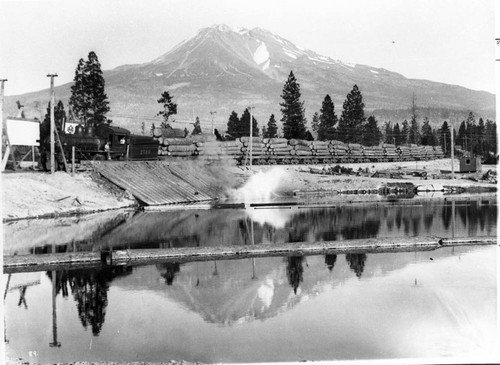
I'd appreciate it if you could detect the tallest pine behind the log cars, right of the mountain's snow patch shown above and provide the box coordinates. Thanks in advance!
[280,71,306,139]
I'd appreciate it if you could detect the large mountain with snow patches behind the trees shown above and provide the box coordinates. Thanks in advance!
[6,25,495,130]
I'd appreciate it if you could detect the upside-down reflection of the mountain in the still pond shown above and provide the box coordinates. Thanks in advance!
[110,247,480,325]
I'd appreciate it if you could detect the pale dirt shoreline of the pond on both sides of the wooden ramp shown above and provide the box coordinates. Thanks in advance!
[2,159,497,223]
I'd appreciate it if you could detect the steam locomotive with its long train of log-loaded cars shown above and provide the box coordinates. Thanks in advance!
[55,125,444,165]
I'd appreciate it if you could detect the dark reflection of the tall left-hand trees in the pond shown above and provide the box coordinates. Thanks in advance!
[47,266,132,336]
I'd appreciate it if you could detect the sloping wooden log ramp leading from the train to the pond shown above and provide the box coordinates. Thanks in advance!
[93,161,224,205]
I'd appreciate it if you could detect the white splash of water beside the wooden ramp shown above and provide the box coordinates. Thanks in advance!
[230,167,287,203]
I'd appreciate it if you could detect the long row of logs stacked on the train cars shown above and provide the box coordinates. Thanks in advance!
[151,133,444,164]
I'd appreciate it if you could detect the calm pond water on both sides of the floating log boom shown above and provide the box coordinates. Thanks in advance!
[3,196,498,363]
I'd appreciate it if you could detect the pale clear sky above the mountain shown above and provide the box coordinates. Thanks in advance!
[0,0,500,95]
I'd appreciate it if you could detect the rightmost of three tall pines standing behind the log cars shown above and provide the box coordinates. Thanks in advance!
[339,85,365,143]
